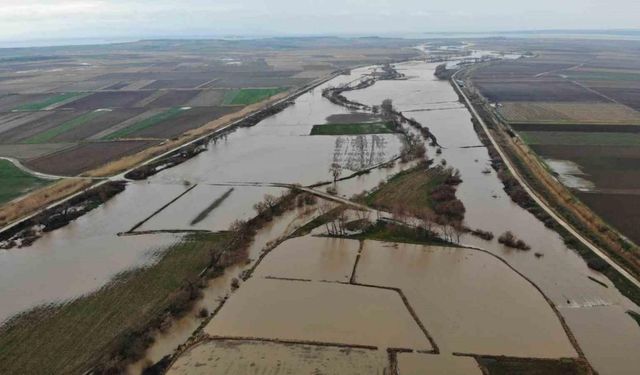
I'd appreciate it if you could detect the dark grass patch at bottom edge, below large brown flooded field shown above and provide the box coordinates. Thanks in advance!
[478,357,590,375]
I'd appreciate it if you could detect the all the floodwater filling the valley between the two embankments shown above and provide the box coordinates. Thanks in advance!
[0,53,640,375]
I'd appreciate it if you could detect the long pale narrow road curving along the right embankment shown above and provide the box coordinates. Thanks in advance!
[451,71,640,288]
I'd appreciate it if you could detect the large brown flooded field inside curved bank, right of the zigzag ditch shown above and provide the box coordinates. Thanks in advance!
[356,241,577,358]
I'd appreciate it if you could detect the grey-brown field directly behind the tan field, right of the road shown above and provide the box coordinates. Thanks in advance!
[475,80,605,102]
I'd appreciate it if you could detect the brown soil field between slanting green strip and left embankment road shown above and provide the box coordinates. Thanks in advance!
[129,107,238,138]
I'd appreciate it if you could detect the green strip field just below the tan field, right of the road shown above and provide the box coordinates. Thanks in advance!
[518,131,640,146]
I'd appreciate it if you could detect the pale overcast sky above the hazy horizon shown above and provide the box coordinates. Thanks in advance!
[0,0,640,42]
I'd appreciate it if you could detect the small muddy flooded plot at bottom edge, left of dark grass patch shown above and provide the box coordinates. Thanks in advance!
[398,353,482,375]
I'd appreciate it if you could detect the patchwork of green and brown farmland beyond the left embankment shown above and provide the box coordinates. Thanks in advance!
[0,38,417,184]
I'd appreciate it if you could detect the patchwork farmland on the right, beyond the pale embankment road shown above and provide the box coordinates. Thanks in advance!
[473,42,640,243]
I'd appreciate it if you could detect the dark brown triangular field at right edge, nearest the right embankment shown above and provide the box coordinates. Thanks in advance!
[577,192,640,243]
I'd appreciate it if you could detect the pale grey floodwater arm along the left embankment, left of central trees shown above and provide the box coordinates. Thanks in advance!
[0,68,401,322]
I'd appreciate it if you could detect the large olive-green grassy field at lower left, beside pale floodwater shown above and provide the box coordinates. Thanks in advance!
[0,233,231,374]
